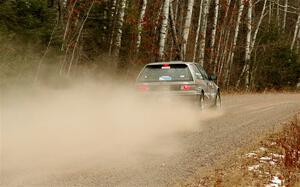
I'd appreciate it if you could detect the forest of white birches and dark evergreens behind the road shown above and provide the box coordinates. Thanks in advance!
[0,0,300,91]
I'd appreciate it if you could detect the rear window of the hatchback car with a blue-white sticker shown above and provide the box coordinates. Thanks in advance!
[138,64,193,82]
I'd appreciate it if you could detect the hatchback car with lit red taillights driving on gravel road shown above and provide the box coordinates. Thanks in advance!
[136,61,221,109]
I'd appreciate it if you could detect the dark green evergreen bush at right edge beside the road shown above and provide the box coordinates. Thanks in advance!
[252,24,300,90]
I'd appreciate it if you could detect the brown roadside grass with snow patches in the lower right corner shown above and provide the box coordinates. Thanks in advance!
[183,113,300,187]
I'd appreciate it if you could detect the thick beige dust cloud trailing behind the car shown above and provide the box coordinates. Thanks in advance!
[0,81,219,186]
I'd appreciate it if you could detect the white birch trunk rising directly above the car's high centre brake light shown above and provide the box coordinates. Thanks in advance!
[158,0,170,60]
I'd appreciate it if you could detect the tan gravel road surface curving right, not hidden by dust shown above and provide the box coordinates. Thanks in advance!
[0,94,300,186]
